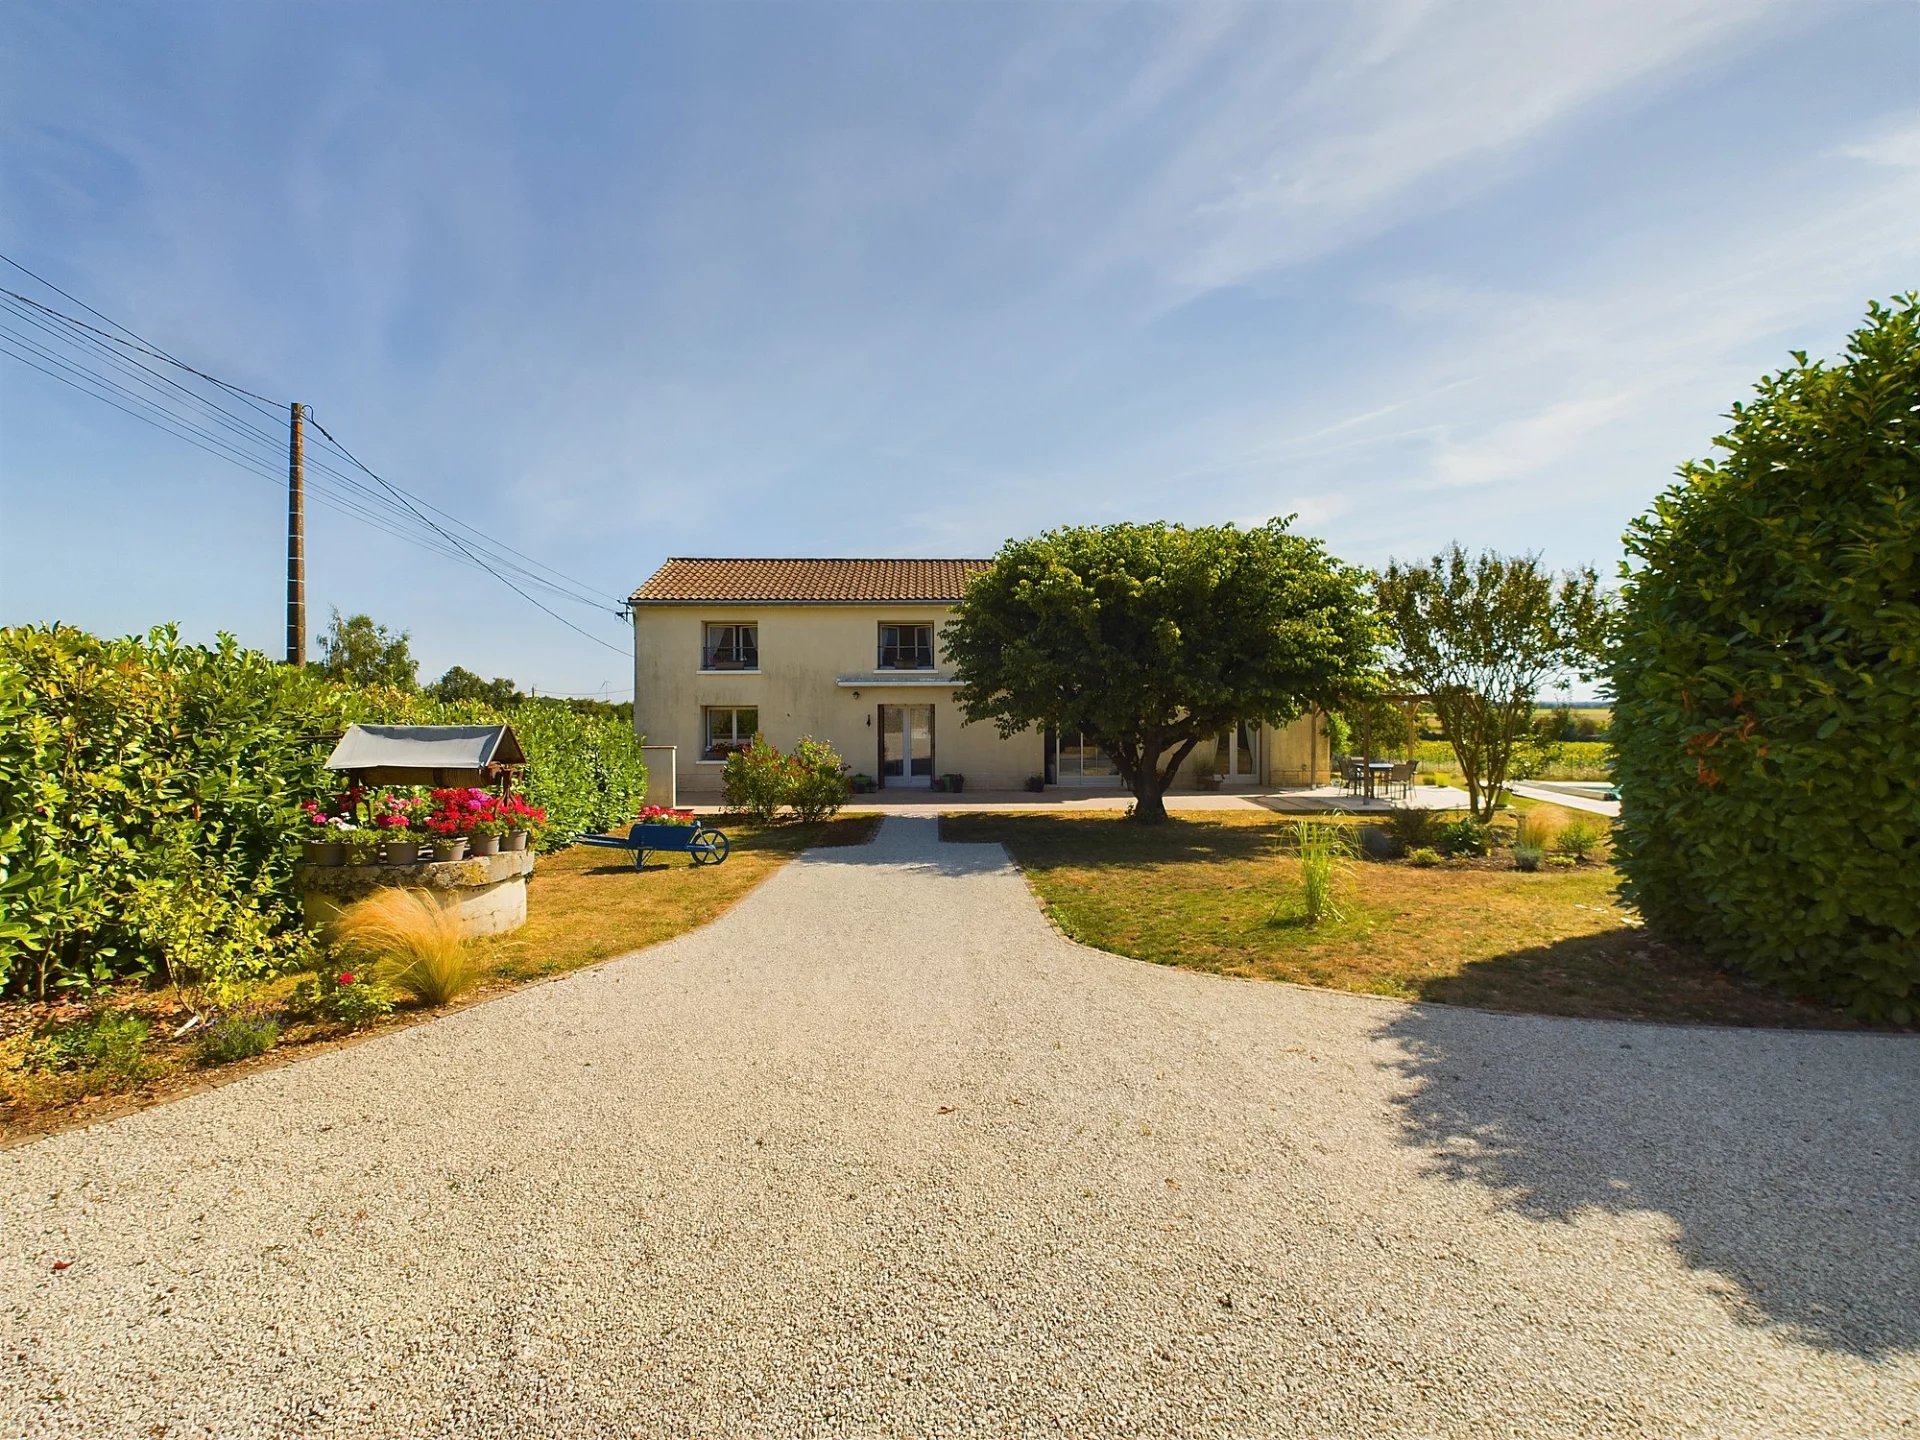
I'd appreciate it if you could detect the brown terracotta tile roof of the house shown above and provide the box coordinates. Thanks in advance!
[634,557,993,605]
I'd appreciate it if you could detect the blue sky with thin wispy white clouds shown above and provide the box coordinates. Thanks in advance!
[0,0,1920,699]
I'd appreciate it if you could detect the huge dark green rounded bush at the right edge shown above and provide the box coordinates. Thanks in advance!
[1613,294,1920,1023]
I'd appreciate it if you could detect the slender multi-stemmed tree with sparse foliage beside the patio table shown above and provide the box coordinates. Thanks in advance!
[1375,545,1607,820]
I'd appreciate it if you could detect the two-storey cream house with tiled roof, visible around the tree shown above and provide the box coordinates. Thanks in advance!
[630,559,1327,801]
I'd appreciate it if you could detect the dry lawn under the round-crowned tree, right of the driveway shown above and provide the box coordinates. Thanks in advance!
[941,806,1851,1027]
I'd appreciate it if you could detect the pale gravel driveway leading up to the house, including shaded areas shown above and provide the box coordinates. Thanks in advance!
[0,818,1920,1440]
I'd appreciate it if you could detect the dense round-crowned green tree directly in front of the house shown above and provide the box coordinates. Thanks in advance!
[943,520,1379,822]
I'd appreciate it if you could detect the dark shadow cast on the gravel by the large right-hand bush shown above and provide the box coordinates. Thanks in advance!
[1377,1004,1920,1359]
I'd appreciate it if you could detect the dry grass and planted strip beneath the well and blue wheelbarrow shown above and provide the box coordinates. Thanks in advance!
[0,814,879,1139]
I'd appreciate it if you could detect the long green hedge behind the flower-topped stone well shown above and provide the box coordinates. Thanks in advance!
[0,626,647,991]
